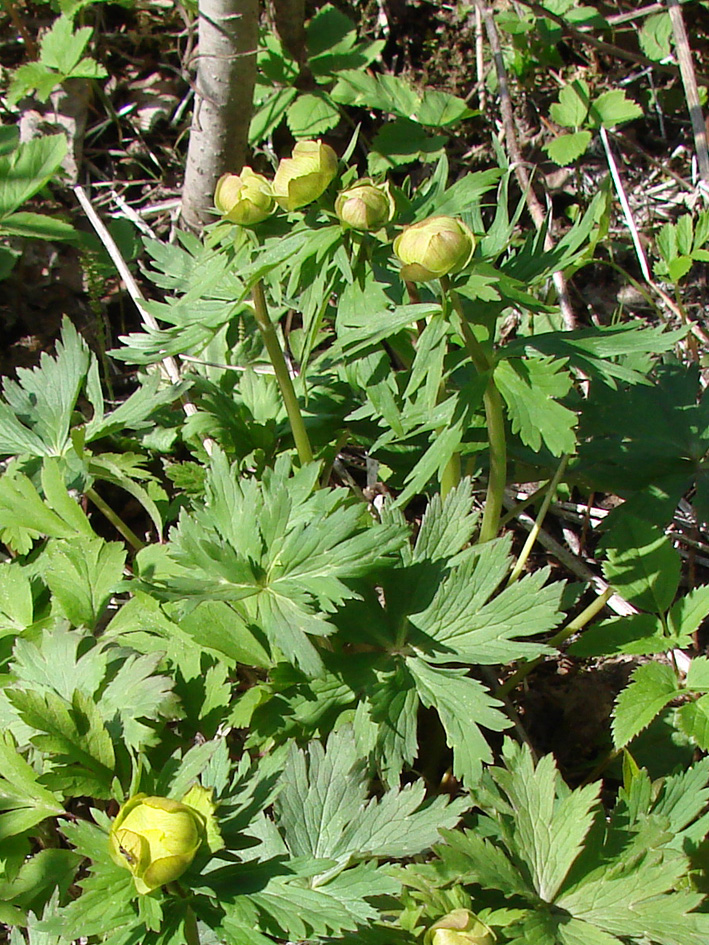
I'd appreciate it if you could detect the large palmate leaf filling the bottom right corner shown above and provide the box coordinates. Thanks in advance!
[439,742,709,945]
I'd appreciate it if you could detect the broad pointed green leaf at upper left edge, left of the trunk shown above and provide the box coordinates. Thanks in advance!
[0,135,67,220]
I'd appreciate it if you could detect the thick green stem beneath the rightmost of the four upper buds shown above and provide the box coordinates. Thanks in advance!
[441,276,507,544]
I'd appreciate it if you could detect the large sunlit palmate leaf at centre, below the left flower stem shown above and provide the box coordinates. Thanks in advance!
[145,454,406,674]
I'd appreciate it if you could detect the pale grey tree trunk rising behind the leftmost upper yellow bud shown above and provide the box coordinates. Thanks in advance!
[181,0,259,232]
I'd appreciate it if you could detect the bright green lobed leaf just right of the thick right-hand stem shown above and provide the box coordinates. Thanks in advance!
[495,358,577,456]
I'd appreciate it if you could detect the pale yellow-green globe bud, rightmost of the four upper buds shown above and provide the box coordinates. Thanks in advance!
[394,217,475,282]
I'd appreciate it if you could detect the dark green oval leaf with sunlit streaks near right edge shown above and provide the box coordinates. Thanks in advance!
[603,515,681,614]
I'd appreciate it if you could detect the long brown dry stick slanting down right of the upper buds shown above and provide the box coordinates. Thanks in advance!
[475,0,576,331]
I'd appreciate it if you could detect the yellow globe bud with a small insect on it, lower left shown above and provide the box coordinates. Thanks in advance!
[108,794,204,895]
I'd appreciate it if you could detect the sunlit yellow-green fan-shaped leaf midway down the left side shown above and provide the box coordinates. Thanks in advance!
[43,538,126,627]
